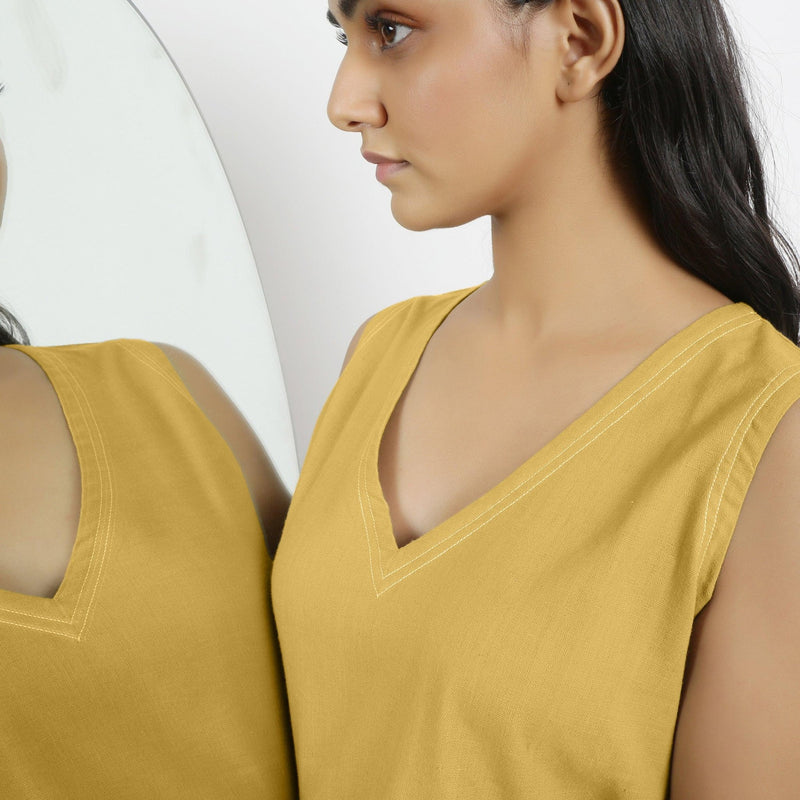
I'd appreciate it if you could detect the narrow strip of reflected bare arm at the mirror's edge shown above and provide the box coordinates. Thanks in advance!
[159,344,291,557]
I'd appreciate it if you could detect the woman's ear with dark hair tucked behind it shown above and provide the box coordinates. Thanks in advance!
[556,0,625,103]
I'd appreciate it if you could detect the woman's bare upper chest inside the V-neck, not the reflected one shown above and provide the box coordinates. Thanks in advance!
[378,334,635,547]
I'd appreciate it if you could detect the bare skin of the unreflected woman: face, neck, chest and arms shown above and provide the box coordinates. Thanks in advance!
[328,0,800,800]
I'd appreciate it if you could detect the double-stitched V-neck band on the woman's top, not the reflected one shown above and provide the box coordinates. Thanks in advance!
[358,284,760,596]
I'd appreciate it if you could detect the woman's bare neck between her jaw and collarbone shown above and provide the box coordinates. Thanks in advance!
[484,112,697,339]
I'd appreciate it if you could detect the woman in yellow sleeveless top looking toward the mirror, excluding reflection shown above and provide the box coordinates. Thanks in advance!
[273,0,800,800]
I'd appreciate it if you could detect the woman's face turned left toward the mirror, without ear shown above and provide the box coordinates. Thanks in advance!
[328,0,568,230]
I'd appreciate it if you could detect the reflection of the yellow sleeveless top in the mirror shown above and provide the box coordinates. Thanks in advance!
[0,340,296,800]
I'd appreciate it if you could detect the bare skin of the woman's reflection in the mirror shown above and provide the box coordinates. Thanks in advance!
[0,142,289,597]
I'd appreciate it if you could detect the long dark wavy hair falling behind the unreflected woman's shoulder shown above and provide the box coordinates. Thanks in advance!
[500,0,800,343]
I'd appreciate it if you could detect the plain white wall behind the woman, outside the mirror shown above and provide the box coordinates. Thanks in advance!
[134,0,800,459]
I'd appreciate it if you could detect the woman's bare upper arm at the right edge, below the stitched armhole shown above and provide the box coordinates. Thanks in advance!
[671,398,800,800]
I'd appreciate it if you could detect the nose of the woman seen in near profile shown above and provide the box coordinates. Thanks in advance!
[328,50,386,132]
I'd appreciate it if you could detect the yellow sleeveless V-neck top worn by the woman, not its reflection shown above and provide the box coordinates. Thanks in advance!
[272,289,800,800]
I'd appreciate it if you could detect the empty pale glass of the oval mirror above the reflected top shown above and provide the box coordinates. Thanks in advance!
[0,0,297,489]
